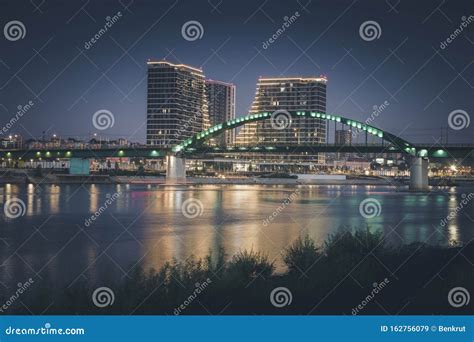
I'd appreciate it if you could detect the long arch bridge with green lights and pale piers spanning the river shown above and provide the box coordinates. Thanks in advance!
[0,110,474,189]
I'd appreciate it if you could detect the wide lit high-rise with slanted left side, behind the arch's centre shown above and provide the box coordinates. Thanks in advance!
[237,77,327,163]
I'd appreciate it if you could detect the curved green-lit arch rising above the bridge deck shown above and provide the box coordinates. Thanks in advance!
[172,110,416,155]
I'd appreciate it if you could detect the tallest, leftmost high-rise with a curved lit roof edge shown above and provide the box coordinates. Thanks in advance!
[146,61,209,147]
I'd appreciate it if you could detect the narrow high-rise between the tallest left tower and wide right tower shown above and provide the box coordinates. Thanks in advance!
[206,80,235,146]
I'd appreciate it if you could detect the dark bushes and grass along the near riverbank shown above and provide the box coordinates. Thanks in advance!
[2,231,474,315]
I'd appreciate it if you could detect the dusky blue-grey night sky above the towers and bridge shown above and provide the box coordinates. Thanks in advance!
[0,0,474,143]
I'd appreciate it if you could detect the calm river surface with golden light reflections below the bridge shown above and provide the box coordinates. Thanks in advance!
[0,184,474,285]
